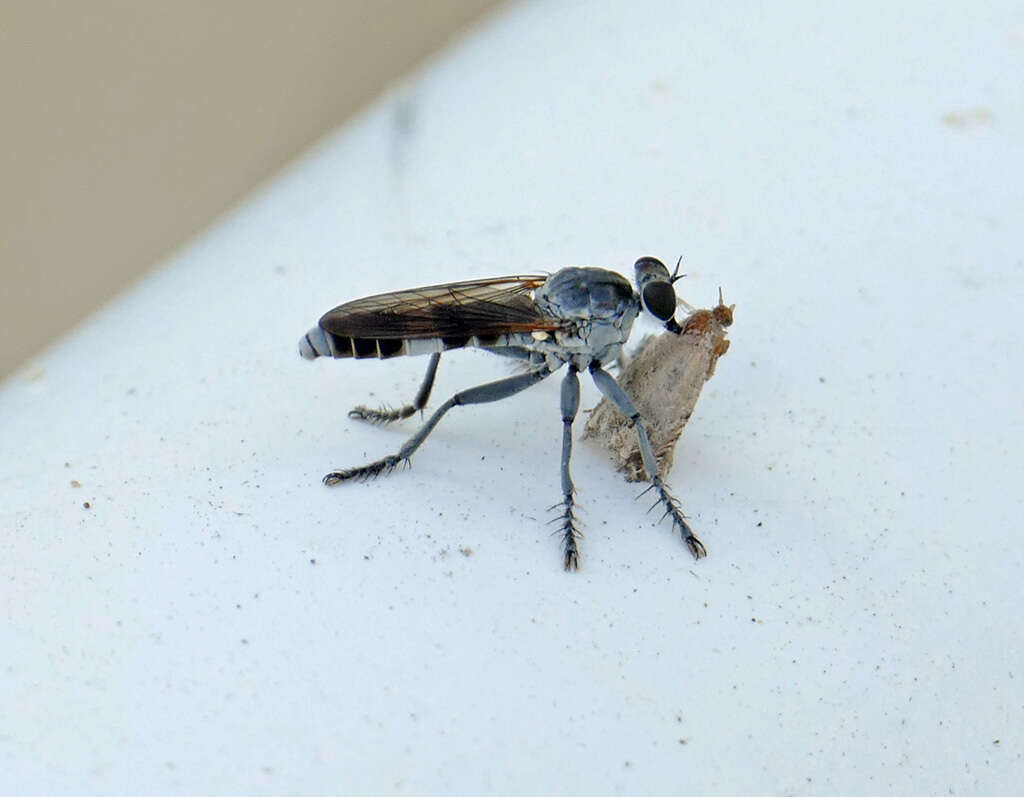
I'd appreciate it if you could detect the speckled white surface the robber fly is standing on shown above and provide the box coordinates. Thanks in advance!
[0,2,1024,795]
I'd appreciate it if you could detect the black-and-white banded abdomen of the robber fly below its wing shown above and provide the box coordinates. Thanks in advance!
[299,327,534,360]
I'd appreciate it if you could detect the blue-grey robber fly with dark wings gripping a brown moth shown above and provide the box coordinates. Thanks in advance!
[299,257,707,570]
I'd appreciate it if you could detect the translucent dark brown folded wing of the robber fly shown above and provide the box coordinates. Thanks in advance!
[319,275,560,340]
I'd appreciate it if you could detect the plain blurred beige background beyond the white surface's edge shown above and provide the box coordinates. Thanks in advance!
[0,0,498,377]
